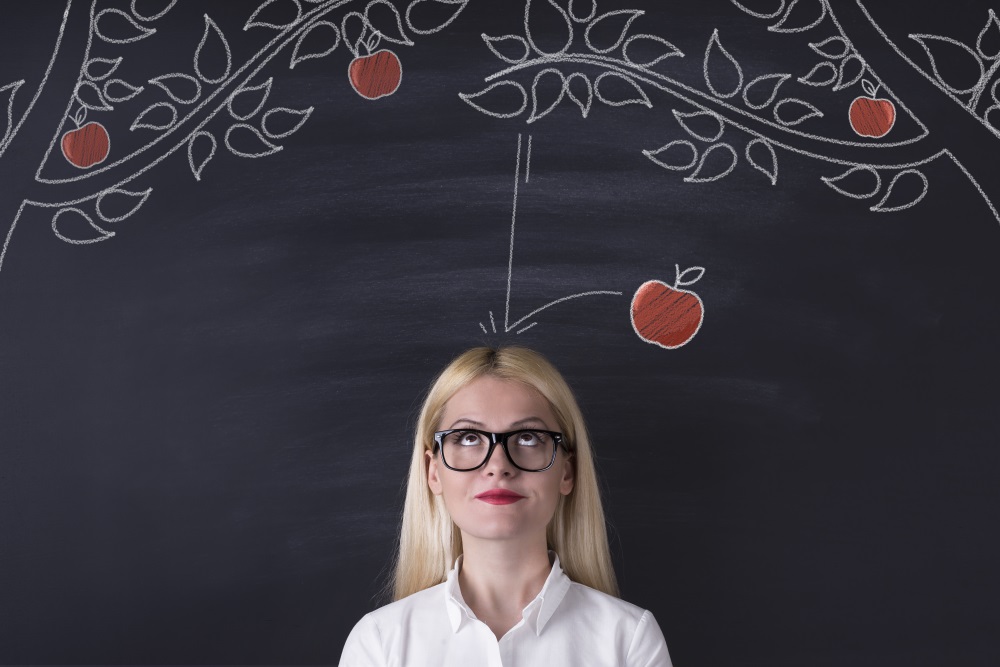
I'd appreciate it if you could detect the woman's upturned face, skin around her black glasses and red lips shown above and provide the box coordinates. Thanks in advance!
[427,375,573,542]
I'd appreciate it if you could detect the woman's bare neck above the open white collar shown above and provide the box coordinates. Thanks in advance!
[458,535,552,639]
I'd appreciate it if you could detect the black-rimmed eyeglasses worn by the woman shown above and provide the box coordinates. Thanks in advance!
[434,428,569,472]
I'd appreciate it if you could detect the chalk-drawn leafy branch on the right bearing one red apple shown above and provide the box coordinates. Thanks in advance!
[459,0,1000,227]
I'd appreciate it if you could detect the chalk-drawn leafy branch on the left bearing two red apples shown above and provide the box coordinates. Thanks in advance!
[0,0,468,268]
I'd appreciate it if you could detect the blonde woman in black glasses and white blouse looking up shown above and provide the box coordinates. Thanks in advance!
[340,347,671,667]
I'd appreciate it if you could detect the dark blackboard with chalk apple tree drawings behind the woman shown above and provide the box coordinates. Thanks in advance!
[0,0,1000,667]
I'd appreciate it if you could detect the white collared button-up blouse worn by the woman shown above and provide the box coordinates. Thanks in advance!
[340,552,671,667]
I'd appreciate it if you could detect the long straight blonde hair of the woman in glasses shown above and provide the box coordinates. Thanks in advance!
[392,347,618,600]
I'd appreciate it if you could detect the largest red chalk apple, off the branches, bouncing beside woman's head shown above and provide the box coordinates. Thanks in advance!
[632,265,705,350]
